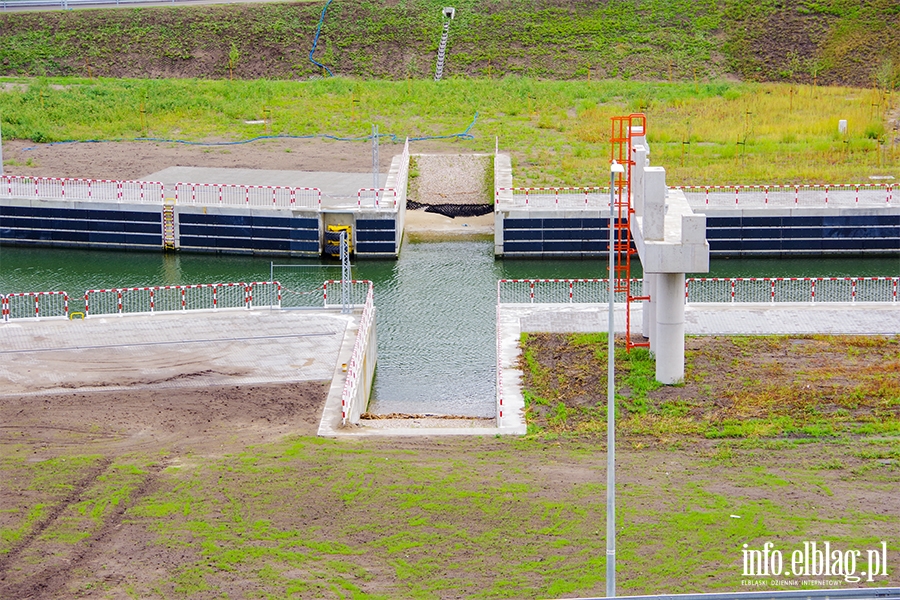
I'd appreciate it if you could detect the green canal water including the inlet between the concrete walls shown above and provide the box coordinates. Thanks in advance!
[0,241,900,416]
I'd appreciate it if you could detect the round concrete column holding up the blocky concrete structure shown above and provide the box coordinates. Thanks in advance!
[650,273,684,385]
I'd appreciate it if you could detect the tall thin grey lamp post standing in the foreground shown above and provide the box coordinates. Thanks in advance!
[606,161,625,598]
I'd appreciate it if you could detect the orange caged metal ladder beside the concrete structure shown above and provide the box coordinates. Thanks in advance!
[609,113,650,352]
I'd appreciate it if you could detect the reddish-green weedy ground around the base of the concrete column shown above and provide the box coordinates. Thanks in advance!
[521,334,900,444]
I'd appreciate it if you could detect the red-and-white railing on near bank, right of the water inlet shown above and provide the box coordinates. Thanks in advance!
[497,277,900,304]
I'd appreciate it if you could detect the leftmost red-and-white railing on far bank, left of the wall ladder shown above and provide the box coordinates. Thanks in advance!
[0,175,166,204]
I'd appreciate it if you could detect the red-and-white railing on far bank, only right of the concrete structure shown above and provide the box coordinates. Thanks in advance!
[673,183,894,208]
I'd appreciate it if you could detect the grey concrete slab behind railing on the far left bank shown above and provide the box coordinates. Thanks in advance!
[141,167,387,207]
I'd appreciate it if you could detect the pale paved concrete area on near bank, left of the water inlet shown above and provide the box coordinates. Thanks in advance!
[0,309,357,396]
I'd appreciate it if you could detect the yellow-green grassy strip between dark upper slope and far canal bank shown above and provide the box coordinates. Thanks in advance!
[0,78,900,185]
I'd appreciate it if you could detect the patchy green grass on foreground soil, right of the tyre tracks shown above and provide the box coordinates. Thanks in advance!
[8,438,898,598]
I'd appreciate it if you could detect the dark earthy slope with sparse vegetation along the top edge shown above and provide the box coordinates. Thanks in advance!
[0,0,900,87]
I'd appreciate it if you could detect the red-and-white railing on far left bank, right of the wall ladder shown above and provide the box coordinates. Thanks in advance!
[174,183,322,208]
